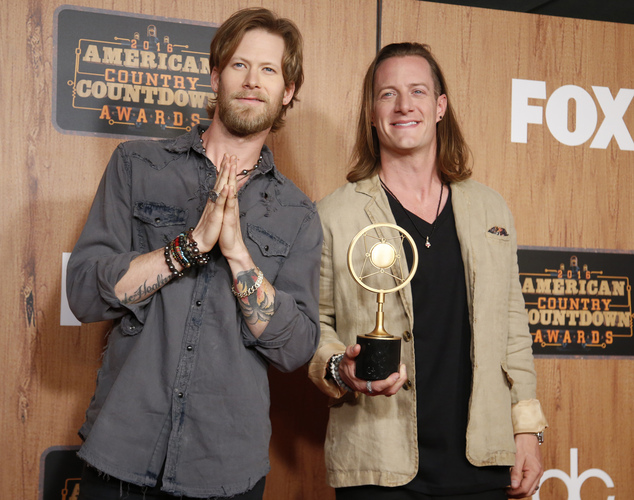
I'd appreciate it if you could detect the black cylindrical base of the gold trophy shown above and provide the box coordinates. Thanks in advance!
[356,335,401,380]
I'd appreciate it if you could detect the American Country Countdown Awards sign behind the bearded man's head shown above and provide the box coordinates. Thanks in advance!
[53,6,216,137]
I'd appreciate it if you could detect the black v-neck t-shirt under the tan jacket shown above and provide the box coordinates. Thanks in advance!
[386,189,511,495]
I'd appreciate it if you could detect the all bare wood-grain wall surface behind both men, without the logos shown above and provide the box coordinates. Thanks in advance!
[0,0,634,500]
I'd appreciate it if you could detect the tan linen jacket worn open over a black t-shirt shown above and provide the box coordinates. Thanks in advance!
[309,176,547,487]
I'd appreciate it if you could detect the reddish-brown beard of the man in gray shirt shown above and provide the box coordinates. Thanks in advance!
[217,81,283,137]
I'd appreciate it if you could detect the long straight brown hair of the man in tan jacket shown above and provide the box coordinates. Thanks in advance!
[347,42,471,182]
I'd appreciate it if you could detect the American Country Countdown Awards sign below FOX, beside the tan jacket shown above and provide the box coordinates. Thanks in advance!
[518,249,634,356]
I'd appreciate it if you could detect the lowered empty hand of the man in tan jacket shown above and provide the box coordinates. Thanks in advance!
[506,434,544,498]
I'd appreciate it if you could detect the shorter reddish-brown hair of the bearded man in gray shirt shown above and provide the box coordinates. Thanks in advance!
[202,7,304,132]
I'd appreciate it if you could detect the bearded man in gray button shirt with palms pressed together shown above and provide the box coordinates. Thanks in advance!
[67,9,322,499]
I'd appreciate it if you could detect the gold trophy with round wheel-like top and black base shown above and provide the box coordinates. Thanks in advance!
[348,223,418,380]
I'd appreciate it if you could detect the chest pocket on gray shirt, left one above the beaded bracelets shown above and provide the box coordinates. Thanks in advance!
[134,201,187,251]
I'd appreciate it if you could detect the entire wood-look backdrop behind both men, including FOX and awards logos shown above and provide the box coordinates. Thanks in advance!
[0,0,634,500]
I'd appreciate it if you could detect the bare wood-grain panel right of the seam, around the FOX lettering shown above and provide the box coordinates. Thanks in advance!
[382,0,634,500]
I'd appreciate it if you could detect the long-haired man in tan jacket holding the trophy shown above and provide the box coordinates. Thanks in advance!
[309,43,547,500]
